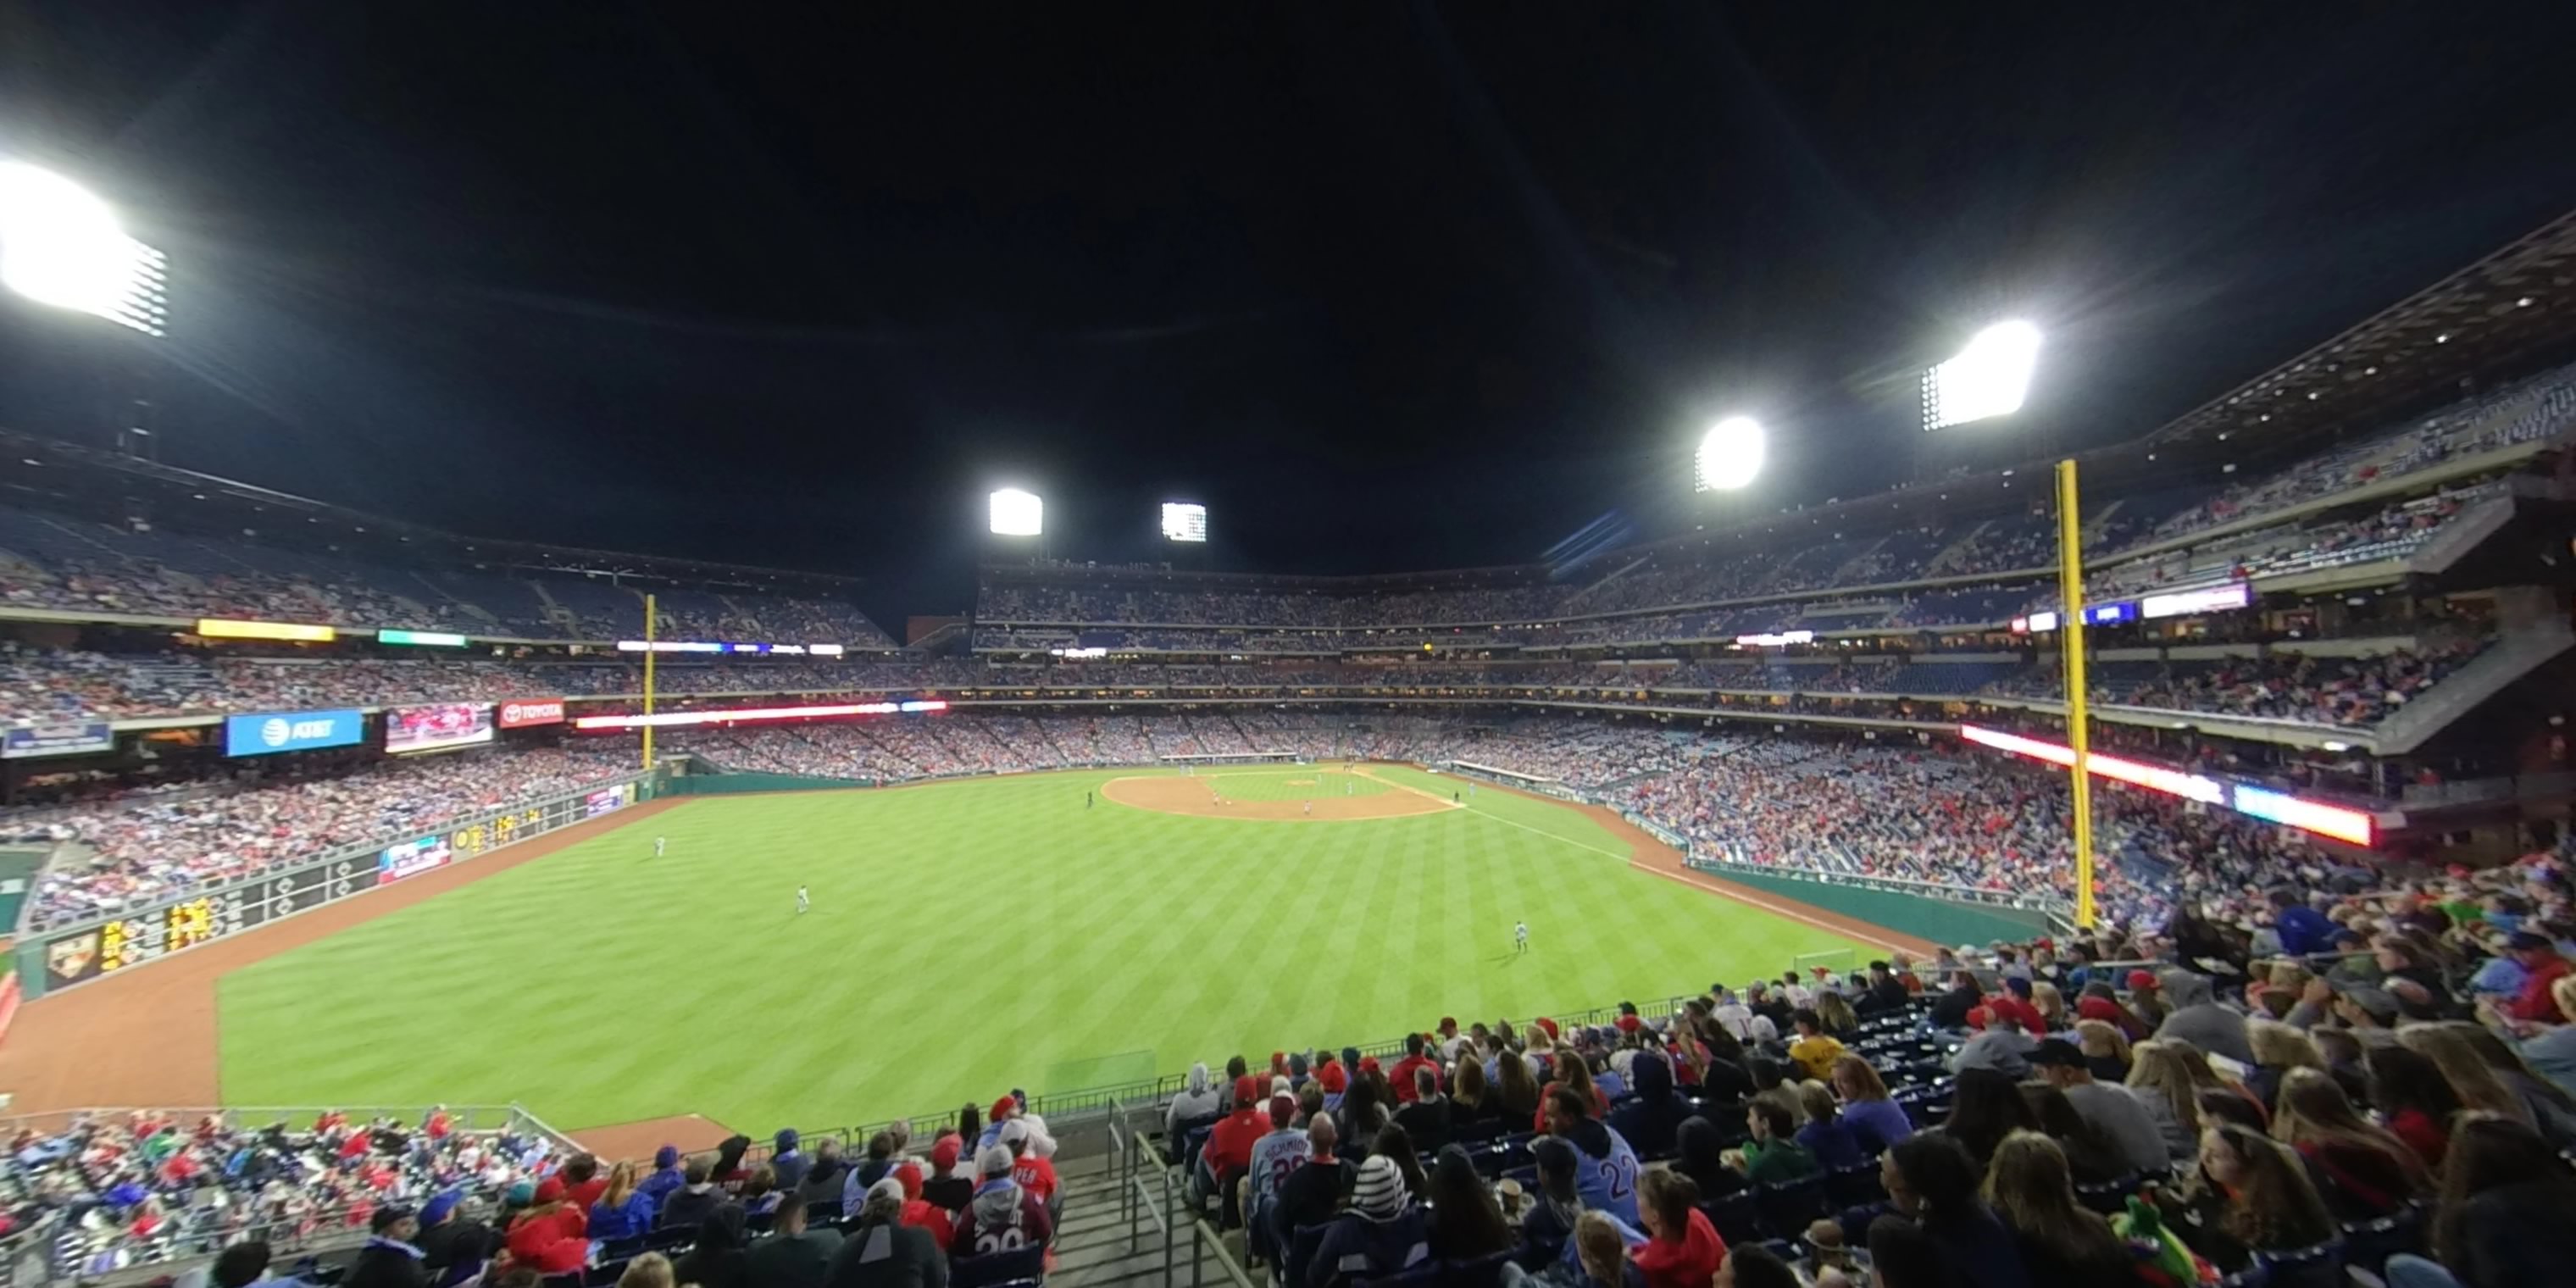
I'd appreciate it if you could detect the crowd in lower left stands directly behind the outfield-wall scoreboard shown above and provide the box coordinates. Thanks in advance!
[19,747,634,927]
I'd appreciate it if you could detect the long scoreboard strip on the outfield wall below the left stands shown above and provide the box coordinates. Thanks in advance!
[44,783,641,991]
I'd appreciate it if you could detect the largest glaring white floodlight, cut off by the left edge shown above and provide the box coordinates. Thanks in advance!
[0,163,168,335]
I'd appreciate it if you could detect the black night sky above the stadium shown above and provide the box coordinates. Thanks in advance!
[0,0,2576,619]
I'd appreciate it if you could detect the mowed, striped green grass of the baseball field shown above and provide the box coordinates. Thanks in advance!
[219,768,1870,1136]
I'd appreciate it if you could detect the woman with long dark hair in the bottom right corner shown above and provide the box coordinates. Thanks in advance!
[2388,1113,2576,1288]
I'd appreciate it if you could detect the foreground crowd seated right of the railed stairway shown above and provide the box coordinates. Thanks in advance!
[1164,840,2576,1288]
